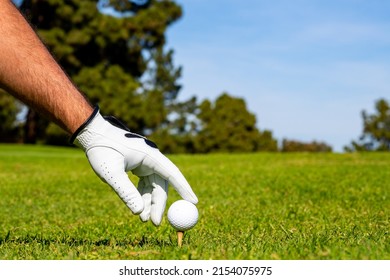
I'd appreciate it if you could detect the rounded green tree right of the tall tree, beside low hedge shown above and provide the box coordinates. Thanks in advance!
[195,93,277,153]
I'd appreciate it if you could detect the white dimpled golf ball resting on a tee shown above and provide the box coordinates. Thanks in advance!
[168,200,199,231]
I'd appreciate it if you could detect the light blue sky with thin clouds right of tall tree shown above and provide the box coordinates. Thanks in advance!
[167,0,390,151]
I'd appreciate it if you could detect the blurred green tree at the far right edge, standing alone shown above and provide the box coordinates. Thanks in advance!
[344,99,390,151]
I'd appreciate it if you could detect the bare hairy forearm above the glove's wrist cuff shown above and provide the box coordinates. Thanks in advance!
[0,0,92,133]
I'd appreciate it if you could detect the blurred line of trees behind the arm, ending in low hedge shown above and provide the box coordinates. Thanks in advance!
[0,0,340,153]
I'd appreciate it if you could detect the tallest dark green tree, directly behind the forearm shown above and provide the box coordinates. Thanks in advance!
[22,0,182,143]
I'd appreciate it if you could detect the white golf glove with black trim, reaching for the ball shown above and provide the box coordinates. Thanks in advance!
[71,107,198,226]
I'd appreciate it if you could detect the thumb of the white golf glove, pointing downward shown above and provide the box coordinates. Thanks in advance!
[86,147,144,214]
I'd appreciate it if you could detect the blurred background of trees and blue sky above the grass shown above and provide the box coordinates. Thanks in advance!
[0,0,390,153]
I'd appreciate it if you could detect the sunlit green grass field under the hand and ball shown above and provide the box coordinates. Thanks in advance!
[0,145,390,260]
